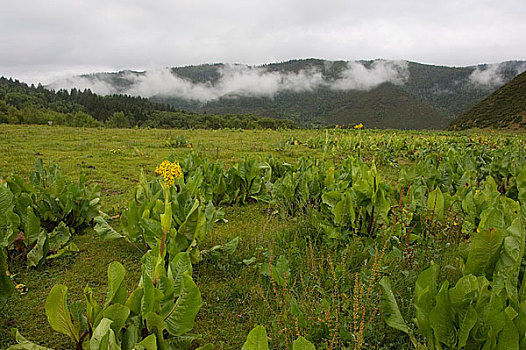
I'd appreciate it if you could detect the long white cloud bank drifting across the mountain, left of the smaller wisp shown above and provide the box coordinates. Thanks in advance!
[49,60,409,102]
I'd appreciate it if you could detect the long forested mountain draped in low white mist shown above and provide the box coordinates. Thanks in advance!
[51,59,526,129]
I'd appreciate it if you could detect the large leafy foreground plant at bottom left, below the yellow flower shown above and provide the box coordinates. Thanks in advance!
[11,251,202,350]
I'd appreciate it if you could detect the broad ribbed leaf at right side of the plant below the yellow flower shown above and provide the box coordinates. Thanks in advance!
[163,271,203,336]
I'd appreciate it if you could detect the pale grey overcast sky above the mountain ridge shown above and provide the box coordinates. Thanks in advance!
[0,0,526,84]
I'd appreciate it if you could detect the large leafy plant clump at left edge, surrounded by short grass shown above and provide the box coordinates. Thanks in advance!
[0,159,100,267]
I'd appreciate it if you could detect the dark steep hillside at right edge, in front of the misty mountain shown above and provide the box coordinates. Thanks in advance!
[449,72,526,130]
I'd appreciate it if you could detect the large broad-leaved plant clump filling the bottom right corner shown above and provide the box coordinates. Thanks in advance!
[381,193,526,349]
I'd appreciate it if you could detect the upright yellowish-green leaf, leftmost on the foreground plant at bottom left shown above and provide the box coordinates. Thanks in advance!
[45,284,79,343]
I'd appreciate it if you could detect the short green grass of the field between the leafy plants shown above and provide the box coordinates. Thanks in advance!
[0,125,522,349]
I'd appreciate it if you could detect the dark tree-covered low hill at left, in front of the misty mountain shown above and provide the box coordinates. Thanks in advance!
[0,77,296,129]
